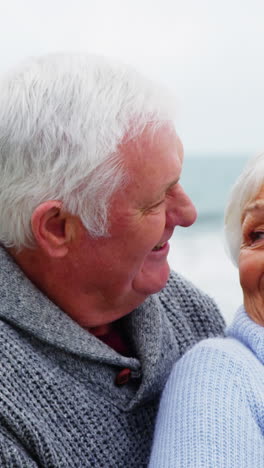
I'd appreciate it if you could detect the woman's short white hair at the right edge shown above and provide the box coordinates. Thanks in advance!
[225,153,264,265]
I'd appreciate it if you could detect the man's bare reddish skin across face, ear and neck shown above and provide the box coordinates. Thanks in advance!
[11,125,196,335]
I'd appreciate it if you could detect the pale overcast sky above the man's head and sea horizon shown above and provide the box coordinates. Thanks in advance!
[0,0,264,156]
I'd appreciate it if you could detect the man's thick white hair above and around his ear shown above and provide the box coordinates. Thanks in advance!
[0,54,175,248]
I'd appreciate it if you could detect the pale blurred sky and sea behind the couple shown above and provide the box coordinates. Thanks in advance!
[0,0,264,323]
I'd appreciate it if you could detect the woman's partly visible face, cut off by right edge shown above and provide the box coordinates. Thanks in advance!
[239,187,264,326]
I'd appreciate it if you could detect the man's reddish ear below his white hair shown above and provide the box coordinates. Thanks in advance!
[31,200,73,258]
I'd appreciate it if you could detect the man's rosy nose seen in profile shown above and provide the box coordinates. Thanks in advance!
[166,184,197,227]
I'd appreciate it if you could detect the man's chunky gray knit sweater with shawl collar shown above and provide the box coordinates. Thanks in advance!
[0,248,224,468]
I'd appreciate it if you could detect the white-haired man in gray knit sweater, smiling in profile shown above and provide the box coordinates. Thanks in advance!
[0,54,223,468]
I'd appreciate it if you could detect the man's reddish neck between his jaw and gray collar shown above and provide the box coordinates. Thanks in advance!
[8,249,145,330]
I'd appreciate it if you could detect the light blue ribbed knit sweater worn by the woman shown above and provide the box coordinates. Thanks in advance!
[149,307,264,468]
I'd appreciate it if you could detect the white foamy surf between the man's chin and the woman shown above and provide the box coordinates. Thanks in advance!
[169,228,242,324]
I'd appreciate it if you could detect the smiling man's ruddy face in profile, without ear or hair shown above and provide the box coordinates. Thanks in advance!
[71,126,196,326]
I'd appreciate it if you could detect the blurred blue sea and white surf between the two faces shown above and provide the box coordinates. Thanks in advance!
[169,155,247,324]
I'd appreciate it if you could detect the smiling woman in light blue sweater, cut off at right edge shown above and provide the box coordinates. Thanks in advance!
[150,154,264,468]
